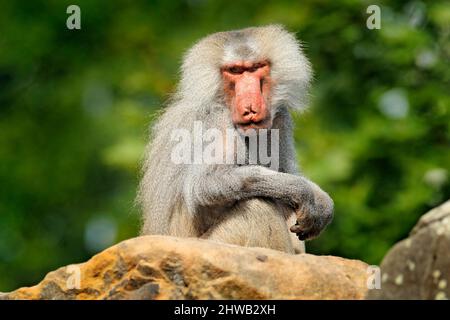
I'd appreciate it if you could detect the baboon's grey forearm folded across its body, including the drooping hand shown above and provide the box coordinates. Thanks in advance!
[184,166,333,240]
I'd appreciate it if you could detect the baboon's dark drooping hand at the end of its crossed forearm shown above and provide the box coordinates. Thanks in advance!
[290,185,333,240]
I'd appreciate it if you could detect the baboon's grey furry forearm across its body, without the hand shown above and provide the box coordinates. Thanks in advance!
[184,166,331,211]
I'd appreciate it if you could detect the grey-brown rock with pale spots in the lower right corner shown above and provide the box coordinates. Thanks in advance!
[367,201,450,299]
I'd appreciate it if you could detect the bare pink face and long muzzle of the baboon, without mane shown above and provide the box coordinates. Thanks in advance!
[221,61,272,131]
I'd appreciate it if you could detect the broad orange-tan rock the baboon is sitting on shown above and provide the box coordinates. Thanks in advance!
[2,236,367,299]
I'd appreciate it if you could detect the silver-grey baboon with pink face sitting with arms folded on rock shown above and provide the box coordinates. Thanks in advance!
[137,25,333,253]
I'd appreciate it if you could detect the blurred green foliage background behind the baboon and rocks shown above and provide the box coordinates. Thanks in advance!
[0,0,450,291]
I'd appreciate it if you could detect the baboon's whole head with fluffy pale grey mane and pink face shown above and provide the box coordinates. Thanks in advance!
[177,26,311,131]
